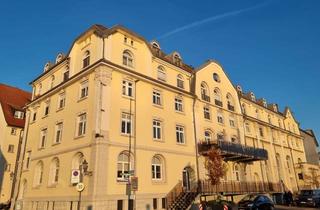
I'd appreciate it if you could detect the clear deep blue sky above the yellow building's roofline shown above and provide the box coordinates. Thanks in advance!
[0,0,320,141]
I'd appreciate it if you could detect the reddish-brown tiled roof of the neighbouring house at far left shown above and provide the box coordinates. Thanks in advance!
[0,83,31,128]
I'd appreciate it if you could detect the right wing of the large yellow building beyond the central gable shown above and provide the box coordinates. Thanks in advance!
[237,86,306,191]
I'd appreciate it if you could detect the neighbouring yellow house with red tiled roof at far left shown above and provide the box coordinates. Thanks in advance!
[0,84,31,204]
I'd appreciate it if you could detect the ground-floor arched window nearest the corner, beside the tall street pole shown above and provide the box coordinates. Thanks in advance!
[117,151,133,180]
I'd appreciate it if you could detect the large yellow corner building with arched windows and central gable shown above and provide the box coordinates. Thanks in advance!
[9,25,312,210]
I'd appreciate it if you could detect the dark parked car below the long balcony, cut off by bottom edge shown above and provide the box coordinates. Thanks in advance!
[238,194,274,210]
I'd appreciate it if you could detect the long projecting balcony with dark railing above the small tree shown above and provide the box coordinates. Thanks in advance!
[198,140,268,162]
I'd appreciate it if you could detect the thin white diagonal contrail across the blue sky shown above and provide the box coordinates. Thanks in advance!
[157,0,271,39]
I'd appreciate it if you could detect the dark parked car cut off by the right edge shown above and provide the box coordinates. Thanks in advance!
[295,189,320,207]
